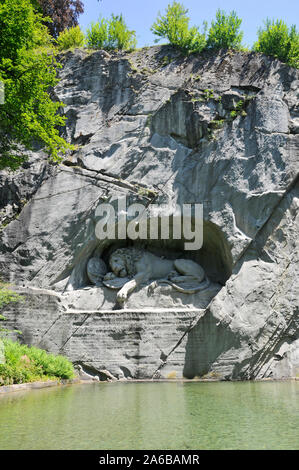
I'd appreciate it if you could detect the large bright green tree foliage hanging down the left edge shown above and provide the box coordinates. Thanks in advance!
[0,0,73,169]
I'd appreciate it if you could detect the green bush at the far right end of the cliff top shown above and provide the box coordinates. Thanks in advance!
[253,19,299,68]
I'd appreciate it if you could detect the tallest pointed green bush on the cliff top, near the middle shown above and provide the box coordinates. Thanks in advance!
[151,2,206,53]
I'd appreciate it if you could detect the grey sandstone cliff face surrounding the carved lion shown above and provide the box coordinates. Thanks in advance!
[0,47,299,380]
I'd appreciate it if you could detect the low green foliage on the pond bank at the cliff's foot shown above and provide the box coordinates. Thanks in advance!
[0,339,75,385]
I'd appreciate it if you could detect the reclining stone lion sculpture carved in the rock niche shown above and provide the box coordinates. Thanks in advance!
[103,248,209,304]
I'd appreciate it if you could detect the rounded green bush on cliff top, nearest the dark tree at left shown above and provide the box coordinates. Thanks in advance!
[86,15,137,51]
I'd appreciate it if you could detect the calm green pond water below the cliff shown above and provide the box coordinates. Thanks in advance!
[0,381,299,450]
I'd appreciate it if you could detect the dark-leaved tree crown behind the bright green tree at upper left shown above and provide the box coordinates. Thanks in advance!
[32,0,84,38]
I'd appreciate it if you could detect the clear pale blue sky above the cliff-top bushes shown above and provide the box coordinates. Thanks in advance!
[79,0,299,47]
